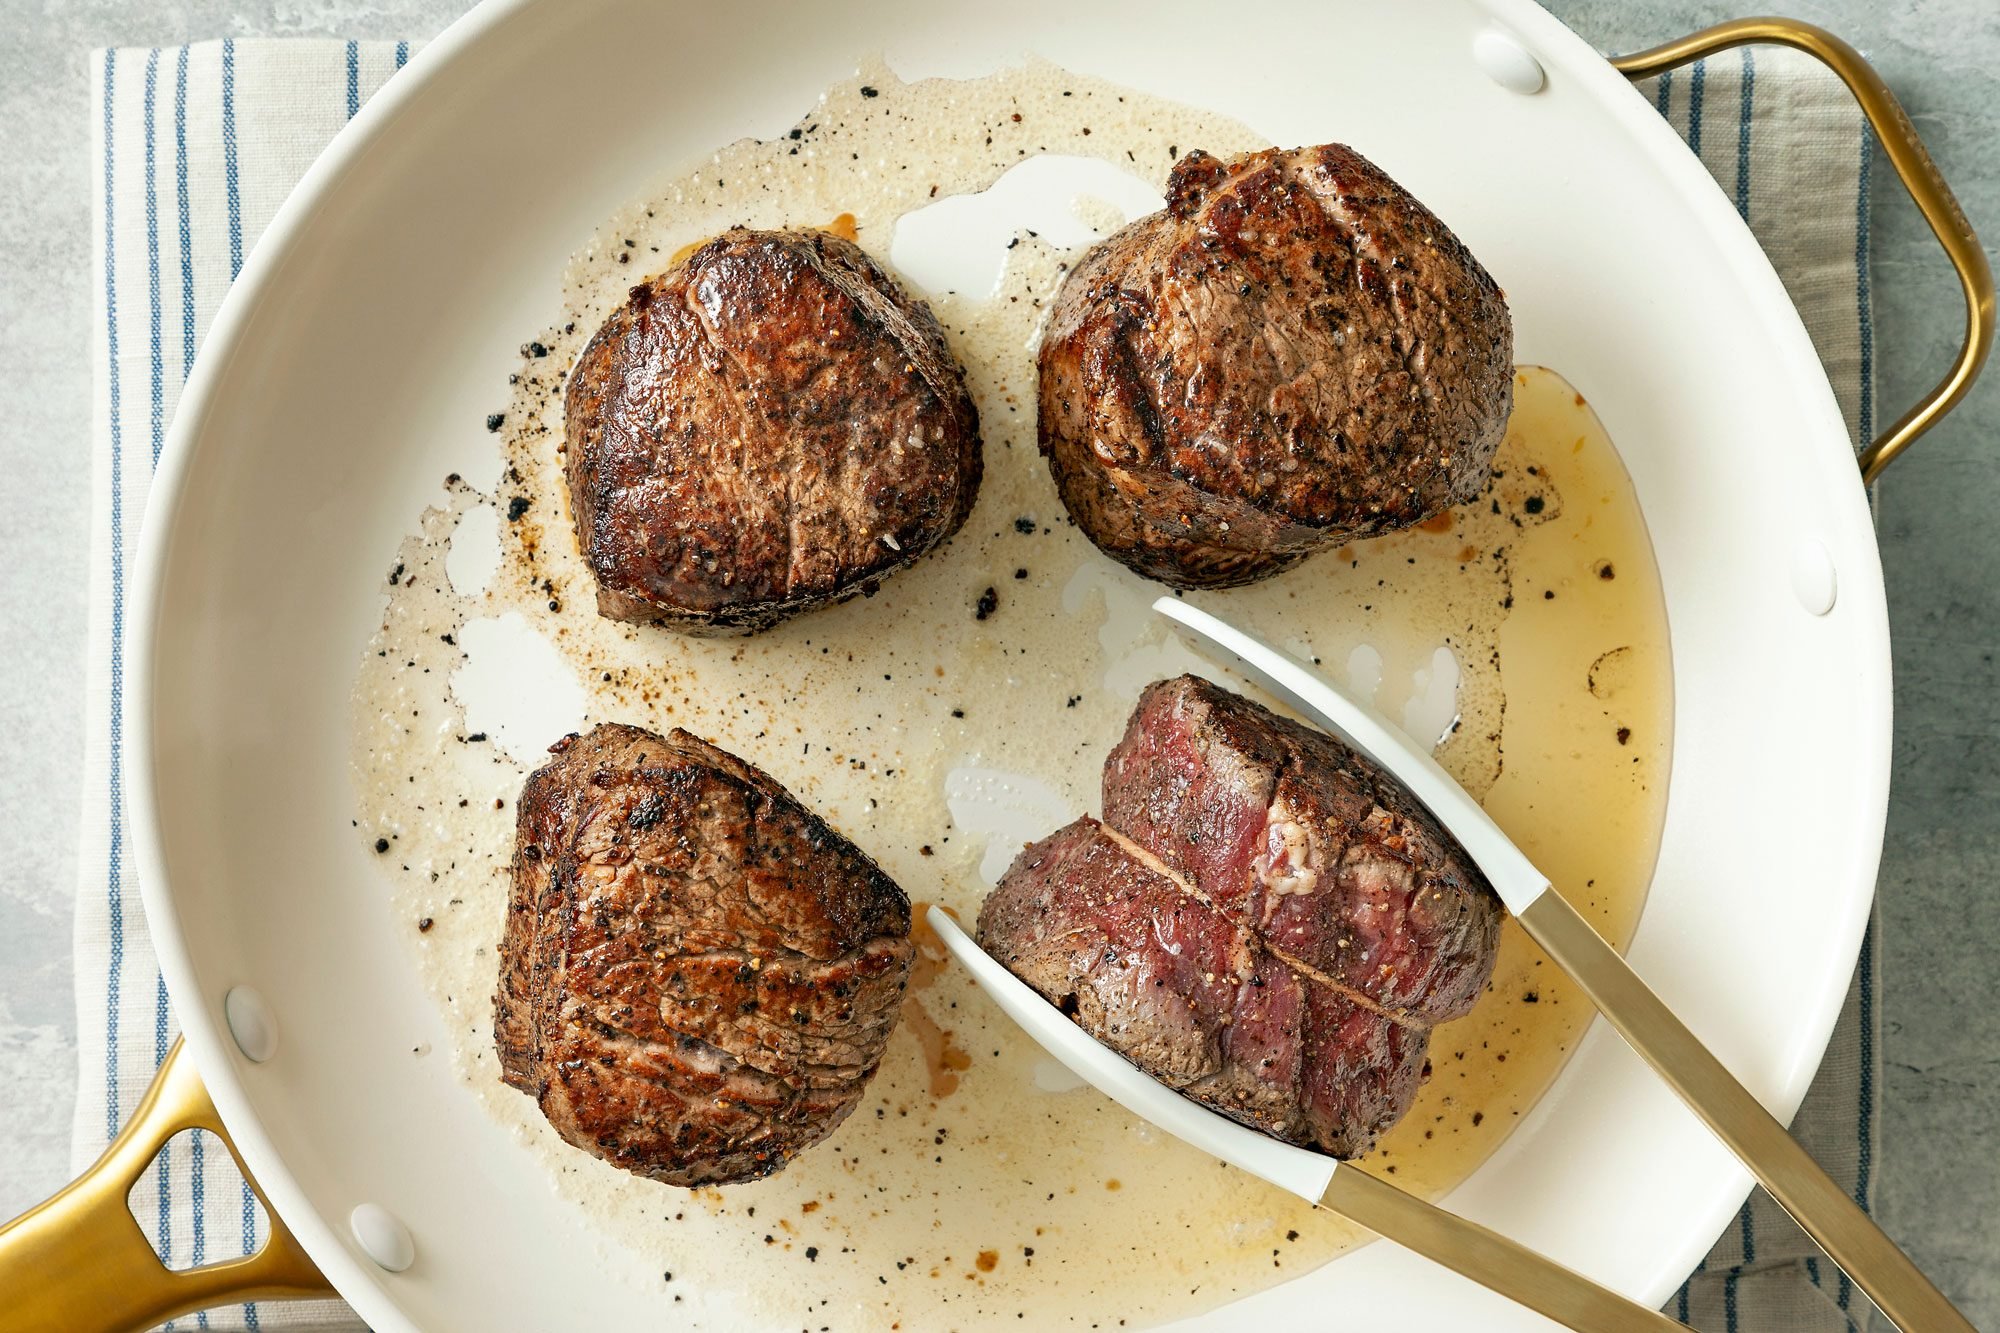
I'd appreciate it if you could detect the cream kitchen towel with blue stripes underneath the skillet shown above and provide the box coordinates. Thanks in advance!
[74,42,1882,1333]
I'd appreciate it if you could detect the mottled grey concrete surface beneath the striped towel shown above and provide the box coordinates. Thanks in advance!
[0,0,2000,1327]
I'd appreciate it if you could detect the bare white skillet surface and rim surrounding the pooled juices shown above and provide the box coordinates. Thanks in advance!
[31,0,1984,1333]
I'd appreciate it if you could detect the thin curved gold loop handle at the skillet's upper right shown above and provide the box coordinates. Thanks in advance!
[1612,18,1994,482]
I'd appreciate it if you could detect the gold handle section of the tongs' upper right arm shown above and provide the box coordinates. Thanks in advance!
[1528,889,1976,1333]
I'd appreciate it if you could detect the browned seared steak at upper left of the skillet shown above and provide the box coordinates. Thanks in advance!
[564,228,980,634]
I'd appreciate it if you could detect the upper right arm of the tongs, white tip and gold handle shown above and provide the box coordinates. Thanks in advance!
[1154,596,1972,1333]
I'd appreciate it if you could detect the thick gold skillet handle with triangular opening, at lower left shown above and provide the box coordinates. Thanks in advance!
[0,1041,334,1333]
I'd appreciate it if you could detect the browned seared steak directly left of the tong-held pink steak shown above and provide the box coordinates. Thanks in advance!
[494,725,914,1187]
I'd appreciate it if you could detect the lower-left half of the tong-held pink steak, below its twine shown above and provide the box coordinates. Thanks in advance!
[978,819,1426,1157]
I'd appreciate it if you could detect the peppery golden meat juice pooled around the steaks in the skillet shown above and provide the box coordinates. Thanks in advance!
[354,64,1672,1329]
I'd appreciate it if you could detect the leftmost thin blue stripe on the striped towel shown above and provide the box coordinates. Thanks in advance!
[104,50,124,1139]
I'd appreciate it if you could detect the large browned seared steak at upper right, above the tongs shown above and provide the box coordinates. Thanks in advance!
[1038,144,1514,588]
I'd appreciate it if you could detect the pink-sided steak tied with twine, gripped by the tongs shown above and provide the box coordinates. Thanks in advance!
[978,677,1500,1157]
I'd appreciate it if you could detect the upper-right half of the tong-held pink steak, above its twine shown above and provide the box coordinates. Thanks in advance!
[1104,677,1500,1025]
